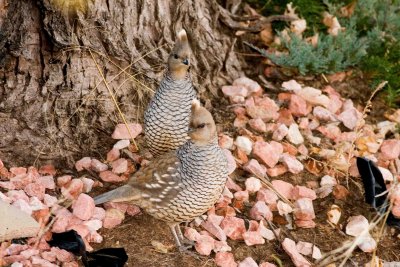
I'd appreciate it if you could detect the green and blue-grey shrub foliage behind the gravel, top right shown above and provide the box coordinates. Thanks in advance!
[248,0,400,104]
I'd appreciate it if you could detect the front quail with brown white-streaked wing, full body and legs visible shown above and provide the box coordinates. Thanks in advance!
[95,100,228,249]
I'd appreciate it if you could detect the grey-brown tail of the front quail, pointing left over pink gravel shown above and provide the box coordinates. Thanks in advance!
[94,185,141,205]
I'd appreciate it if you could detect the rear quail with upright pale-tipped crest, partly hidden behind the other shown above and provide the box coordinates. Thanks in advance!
[144,30,196,156]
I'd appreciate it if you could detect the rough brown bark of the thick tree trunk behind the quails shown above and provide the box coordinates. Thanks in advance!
[0,0,241,166]
